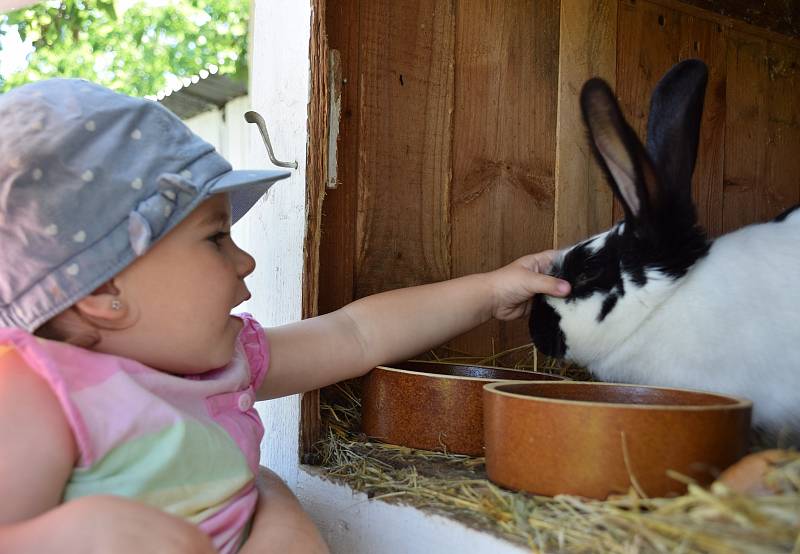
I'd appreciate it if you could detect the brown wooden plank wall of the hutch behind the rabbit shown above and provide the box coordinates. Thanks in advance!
[319,0,800,355]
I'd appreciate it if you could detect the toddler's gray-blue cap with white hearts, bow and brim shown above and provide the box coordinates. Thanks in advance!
[0,79,289,331]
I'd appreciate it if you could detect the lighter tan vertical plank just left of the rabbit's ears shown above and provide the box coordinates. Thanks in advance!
[553,0,618,248]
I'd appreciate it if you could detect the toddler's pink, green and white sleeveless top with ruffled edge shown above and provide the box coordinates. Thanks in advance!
[0,314,269,552]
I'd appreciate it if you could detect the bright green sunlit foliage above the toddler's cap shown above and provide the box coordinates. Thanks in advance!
[0,0,249,96]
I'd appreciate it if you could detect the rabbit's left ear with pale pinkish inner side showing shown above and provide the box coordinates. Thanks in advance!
[581,79,658,224]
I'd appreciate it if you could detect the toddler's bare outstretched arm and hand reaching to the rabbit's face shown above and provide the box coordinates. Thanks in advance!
[259,251,569,399]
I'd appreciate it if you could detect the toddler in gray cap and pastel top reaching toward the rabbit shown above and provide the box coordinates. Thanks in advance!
[0,79,569,552]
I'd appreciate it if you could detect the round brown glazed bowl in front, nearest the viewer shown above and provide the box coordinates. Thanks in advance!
[483,381,752,499]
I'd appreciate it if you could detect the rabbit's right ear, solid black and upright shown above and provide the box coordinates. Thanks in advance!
[647,60,708,195]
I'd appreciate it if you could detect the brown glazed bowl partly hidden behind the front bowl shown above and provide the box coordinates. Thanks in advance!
[361,362,565,456]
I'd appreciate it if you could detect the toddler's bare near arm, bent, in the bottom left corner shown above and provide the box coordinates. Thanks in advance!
[0,346,214,554]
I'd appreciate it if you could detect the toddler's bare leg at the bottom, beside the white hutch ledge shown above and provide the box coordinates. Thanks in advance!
[240,467,328,554]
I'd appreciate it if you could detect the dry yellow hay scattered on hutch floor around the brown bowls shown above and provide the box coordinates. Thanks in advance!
[318,344,800,554]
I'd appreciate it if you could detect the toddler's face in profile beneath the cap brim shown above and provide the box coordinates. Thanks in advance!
[95,194,255,374]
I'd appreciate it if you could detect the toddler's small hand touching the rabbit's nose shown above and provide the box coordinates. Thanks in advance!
[488,250,570,321]
